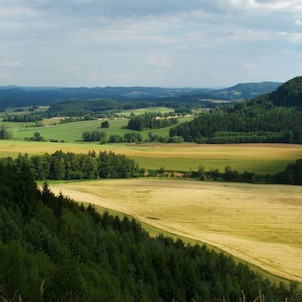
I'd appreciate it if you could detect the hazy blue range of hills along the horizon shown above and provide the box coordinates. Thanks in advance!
[0,82,280,109]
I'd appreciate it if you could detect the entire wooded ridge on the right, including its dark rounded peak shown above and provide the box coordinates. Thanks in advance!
[170,77,302,144]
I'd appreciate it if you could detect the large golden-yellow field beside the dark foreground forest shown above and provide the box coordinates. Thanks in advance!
[51,179,302,282]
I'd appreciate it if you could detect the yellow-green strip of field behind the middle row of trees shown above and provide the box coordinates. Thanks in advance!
[0,140,302,174]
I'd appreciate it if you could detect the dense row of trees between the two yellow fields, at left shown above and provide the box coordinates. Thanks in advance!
[1,151,140,180]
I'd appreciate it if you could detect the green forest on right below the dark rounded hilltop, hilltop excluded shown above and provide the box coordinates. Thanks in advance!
[170,108,302,144]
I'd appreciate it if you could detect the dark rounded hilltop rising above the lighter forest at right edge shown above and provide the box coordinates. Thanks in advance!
[270,76,302,107]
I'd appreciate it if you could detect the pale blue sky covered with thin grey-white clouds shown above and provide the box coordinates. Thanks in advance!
[0,0,302,87]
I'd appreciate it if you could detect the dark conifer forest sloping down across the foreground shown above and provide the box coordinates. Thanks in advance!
[0,163,302,302]
